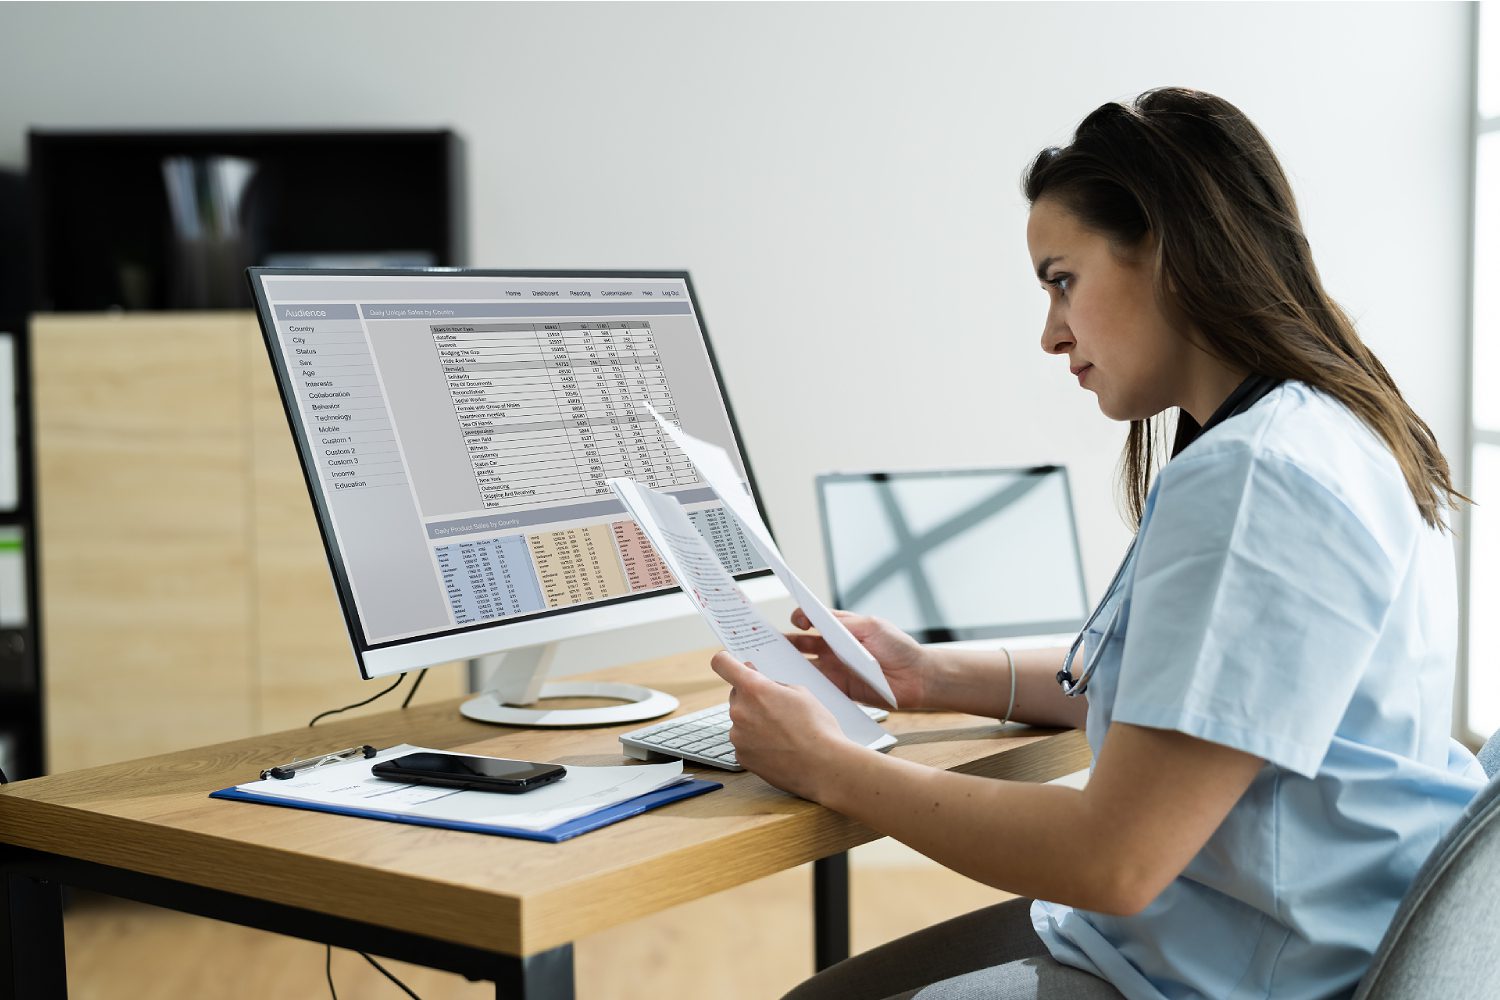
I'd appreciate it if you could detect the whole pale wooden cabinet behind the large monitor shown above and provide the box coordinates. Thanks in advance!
[32,312,464,772]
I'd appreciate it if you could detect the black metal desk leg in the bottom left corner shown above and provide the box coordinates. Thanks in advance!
[0,873,68,1000]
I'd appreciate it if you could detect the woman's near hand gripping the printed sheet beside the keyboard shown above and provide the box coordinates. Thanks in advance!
[710,649,848,802]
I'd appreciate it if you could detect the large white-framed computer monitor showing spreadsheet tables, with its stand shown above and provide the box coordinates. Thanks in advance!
[249,268,785,726]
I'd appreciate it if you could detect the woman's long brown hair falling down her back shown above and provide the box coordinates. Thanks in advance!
[1023,87,1467,528]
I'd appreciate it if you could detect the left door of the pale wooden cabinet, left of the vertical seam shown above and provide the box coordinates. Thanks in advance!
[32,313,257,772]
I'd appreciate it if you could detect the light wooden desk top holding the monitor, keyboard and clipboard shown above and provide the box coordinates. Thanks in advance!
[0,652,1088,955]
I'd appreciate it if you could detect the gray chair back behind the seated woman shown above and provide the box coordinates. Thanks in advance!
[1355,733,1500,1000]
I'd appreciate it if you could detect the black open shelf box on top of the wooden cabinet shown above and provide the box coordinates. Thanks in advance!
[29,129,468,312]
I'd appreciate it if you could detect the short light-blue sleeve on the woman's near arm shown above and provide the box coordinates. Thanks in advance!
[1113,448,1398,778]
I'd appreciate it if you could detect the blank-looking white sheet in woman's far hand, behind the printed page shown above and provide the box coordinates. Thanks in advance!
[642,403,896,708]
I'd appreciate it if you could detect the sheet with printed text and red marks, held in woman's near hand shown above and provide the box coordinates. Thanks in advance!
[609,478,896,748]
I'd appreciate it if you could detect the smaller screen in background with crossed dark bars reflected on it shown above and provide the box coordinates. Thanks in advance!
[818,466,1088,642]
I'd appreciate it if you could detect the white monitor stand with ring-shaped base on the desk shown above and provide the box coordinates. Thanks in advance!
[459,642,677,727]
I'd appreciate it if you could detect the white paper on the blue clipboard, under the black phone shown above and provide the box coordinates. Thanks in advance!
[237,744,690,831]
